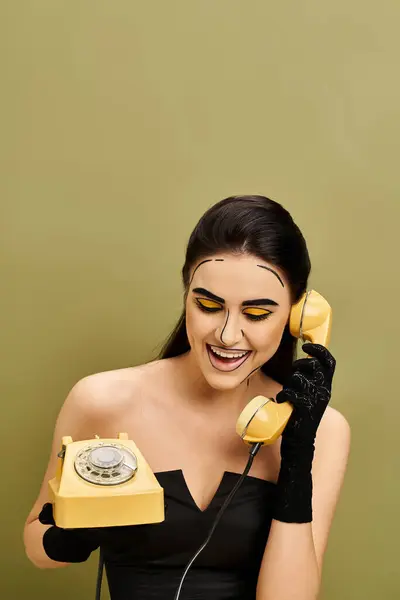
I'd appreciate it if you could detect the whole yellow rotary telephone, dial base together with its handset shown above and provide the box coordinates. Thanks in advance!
[49,290,332,529]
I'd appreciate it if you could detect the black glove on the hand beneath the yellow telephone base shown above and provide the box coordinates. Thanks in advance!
[39,502,100,563]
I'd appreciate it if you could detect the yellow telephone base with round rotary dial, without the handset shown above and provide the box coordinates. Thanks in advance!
[49,434,164,529]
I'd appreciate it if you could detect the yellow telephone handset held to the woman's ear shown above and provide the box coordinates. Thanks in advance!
[236,290,332,444]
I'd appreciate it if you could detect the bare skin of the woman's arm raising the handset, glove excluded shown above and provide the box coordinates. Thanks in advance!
[257,409,350,600]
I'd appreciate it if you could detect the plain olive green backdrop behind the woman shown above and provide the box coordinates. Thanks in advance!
[0,0,400,600]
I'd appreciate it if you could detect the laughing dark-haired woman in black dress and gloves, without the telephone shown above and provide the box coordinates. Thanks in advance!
[24,196,350,600]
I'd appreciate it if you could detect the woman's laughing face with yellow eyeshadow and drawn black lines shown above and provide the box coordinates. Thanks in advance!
[186,254,291,390]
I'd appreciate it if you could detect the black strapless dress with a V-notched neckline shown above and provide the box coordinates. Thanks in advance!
[103,470,276,600]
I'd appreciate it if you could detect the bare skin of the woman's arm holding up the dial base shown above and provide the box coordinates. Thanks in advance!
[23,375,105,569]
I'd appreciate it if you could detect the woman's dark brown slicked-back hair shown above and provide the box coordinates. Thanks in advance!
[158,196,311,384]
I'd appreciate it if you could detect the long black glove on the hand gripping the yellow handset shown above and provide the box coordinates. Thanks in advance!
[273,343,336,523]
